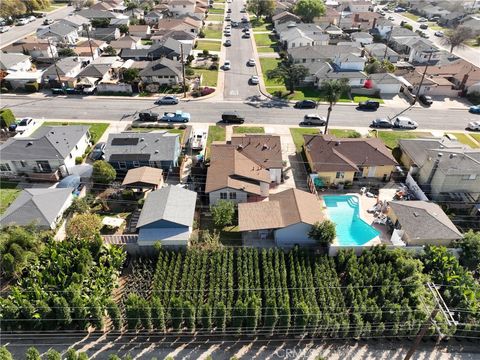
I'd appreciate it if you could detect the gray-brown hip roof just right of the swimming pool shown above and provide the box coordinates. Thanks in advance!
[389,201,462,240]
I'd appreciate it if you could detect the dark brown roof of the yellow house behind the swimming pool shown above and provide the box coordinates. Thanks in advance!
[303,135,397,172]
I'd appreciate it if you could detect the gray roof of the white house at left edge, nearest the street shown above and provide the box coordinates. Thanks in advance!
[0,125,89,160]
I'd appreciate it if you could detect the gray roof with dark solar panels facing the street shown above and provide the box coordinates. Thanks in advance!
[105,132,179,161]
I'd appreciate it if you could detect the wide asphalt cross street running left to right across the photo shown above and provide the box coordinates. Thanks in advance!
[1,94,474,130]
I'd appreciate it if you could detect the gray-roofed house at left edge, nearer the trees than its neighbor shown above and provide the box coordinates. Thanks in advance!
[0,188,74,230]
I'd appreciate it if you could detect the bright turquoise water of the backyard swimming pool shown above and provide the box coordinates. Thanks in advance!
[323,195,380,246]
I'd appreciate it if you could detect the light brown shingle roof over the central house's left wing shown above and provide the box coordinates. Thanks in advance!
[205,143,270,195]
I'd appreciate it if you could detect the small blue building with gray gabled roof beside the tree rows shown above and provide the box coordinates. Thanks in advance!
[137,186,197,247]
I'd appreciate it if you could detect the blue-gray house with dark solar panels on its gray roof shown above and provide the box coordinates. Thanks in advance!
[104,131,181,172]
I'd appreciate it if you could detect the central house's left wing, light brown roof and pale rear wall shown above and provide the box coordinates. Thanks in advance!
[205,143,271,205]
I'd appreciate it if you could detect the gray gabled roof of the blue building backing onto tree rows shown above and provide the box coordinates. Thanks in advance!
[137,186,197,228]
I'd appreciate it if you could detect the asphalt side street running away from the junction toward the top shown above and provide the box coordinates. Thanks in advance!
[223,0,260,100]
